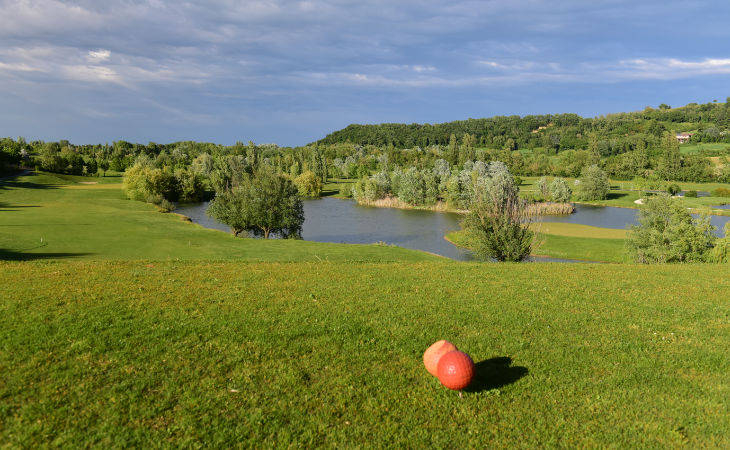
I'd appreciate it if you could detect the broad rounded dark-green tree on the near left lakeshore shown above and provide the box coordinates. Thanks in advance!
[206,166,304,239]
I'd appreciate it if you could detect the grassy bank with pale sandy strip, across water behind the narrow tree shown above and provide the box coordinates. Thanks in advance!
[446,222,630,263]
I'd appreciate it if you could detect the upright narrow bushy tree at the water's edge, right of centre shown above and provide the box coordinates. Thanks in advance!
[462,172,535,261]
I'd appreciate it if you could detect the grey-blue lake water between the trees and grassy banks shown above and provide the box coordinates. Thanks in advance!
[176,197,730,261]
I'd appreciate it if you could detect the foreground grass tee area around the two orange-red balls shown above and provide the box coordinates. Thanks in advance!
[0,261,730,448]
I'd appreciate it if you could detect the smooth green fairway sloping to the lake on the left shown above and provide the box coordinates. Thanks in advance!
[0,175,438,261]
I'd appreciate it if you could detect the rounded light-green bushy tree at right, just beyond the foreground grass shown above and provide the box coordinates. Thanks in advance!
[627,195,716,264]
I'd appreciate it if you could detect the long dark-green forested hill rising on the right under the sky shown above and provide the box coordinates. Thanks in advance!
[316,97,730,149]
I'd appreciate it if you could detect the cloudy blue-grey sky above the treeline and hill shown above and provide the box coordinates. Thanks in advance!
[0,0,730,146]
